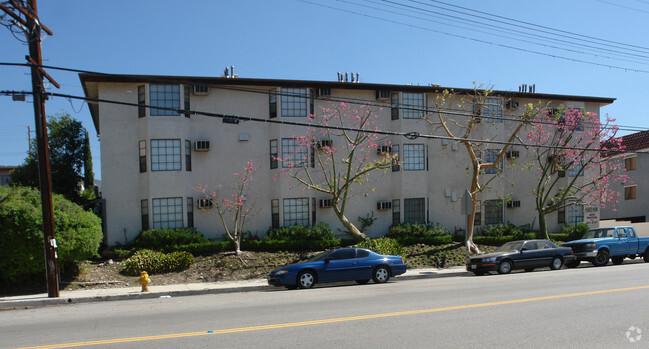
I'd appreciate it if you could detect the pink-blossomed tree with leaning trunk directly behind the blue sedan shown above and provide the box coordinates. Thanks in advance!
[278,102,397,240]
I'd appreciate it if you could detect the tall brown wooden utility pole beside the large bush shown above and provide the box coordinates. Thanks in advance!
[0,0,59,297]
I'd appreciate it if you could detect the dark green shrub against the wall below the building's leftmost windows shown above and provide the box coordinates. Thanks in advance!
[133,228,208,251]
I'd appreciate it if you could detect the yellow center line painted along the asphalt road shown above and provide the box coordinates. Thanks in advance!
[19,285,649,349]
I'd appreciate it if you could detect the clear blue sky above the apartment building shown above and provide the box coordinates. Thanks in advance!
[0,0,649,178]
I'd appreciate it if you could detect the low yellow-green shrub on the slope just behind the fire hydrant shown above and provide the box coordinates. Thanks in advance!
[120,250,195,276]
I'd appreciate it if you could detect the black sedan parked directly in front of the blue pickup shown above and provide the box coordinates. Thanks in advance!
[466,240,575,275]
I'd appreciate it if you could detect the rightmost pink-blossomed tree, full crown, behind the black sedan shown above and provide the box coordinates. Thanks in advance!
[527,107,629,238]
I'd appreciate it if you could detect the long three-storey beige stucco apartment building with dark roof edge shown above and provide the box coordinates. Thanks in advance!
[80,74,614,246]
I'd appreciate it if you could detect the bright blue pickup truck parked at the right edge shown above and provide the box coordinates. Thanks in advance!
[563,226,649,268]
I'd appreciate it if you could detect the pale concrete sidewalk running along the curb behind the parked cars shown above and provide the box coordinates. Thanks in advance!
[0,266,466,310]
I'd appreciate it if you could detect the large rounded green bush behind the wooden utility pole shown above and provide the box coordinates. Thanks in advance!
[0,186,103,285]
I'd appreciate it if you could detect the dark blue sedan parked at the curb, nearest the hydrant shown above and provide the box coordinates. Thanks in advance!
[268,248,407,289]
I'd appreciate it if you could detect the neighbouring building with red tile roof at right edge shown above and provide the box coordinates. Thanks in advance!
[601,131,649,223]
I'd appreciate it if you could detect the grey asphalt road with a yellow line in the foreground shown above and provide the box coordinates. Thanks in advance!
[0,261,649,349]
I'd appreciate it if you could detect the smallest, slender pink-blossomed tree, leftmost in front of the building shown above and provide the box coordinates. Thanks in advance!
[197,161,257,255]
